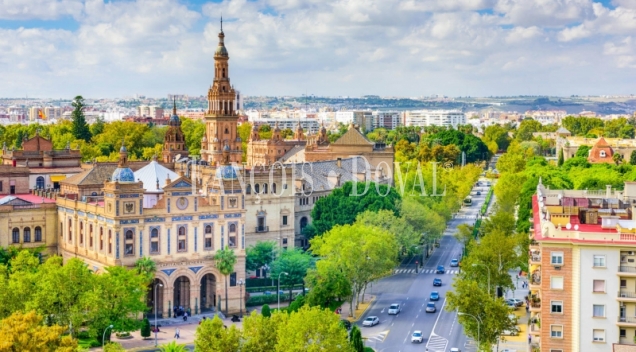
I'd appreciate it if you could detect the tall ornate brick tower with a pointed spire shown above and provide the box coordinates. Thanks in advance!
[201,19,243,165]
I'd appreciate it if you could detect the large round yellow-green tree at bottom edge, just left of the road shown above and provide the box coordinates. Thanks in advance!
[276,306,351,352]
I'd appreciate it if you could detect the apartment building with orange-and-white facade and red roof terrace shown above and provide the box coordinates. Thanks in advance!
[529,181,636,352]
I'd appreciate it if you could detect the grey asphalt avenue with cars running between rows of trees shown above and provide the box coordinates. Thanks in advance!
[358,179,488,352]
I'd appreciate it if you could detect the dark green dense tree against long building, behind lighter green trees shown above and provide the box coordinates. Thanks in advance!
[311,182,401,235]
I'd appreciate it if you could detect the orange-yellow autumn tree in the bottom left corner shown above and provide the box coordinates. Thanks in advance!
[0,311,77,352]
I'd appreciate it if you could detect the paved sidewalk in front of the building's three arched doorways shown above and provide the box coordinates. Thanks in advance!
[90,302,289,352]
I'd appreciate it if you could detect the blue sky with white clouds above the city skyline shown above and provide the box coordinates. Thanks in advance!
[0,0,636,98]
